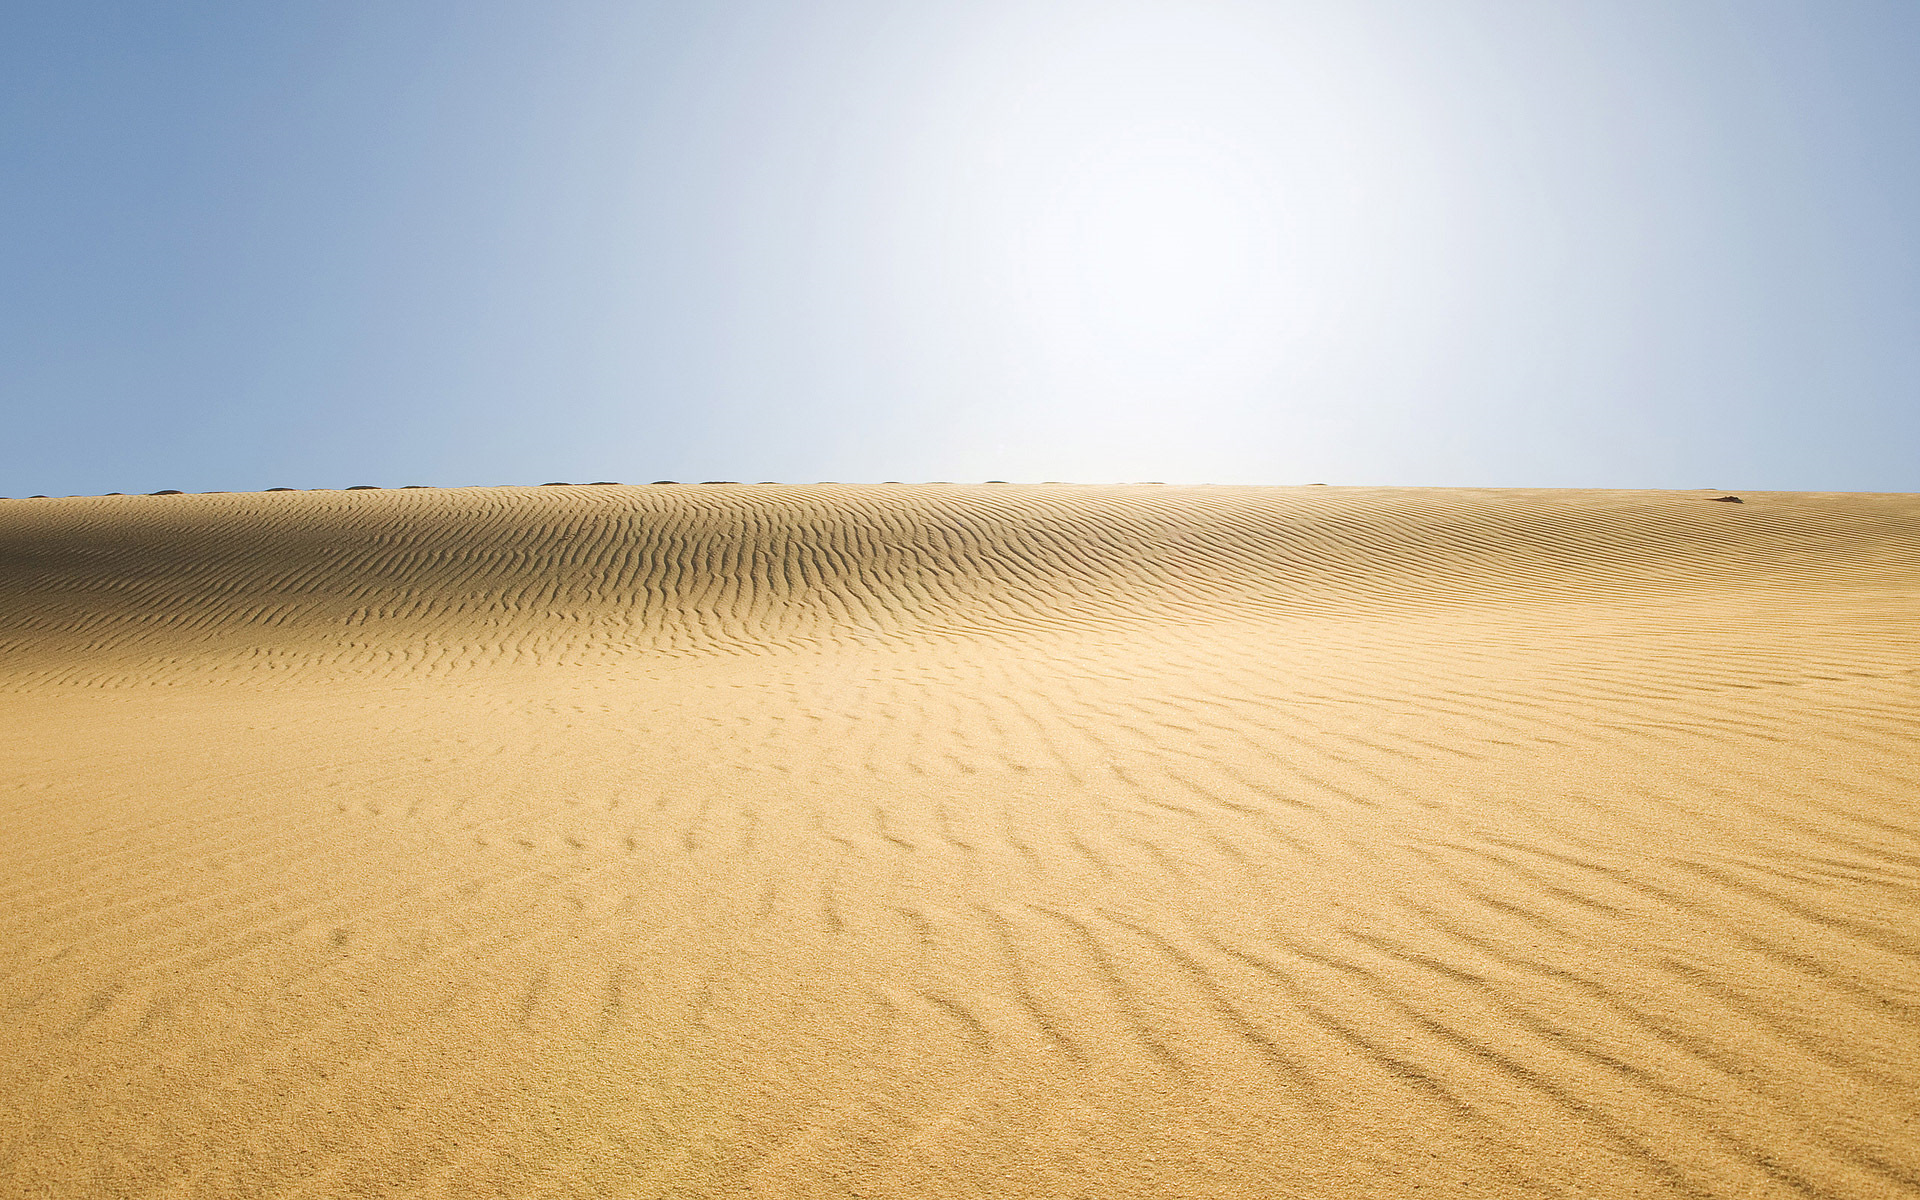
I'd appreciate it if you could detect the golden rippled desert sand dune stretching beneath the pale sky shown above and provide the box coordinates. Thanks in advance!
[0,486,1920,1200]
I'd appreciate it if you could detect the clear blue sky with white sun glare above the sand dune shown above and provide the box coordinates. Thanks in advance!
[0,0,1920,495]
